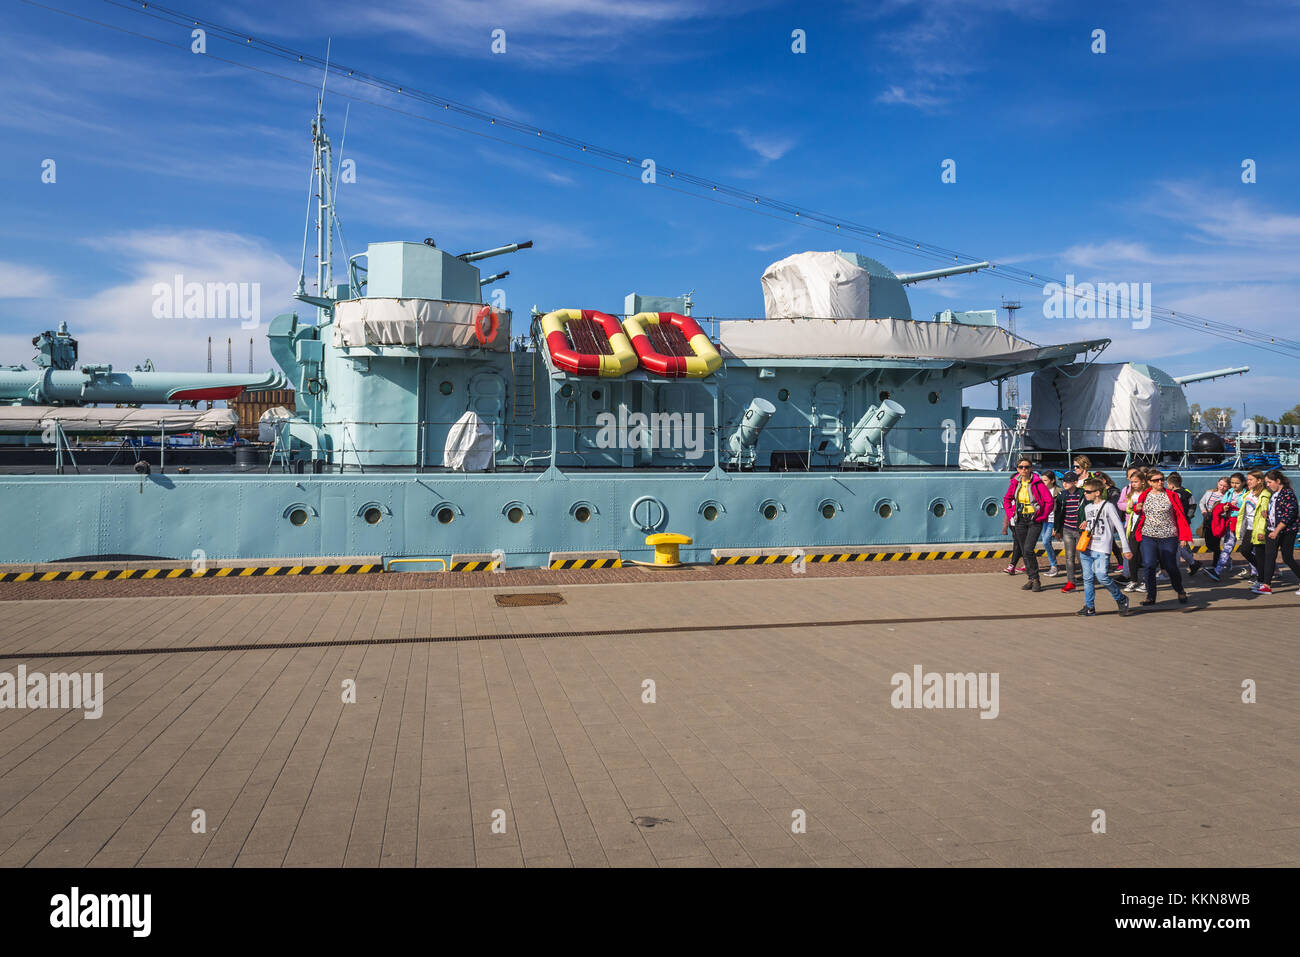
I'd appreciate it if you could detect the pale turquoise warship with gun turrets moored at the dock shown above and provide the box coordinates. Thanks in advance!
[0,105,1300,570]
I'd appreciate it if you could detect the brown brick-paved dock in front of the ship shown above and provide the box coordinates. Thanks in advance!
[0,572,1300,867]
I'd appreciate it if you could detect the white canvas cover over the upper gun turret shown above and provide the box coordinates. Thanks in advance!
[763,252,871,319]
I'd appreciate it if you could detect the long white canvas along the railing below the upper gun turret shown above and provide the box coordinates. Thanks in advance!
[718,315,1039,360]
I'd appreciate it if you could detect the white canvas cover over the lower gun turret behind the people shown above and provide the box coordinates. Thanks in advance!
[1027,363,1160,455]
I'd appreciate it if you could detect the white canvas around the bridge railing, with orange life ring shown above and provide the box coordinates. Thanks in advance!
[334,298,510,352]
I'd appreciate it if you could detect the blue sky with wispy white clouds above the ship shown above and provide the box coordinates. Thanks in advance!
[0,0,1300,415]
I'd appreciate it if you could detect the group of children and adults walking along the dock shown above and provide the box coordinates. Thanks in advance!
[1002,455,1300,616]
